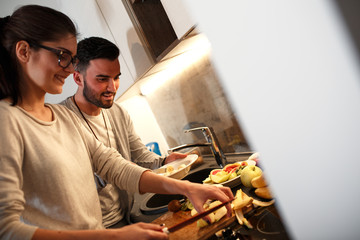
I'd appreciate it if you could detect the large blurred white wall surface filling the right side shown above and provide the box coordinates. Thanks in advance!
[187,0,360,239]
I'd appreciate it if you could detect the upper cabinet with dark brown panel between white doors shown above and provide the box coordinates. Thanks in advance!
[97,0,195,82]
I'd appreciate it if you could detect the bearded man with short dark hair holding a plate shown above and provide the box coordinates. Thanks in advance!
[62,37,186,228]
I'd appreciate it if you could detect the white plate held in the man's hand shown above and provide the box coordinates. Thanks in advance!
[153,154,198,179]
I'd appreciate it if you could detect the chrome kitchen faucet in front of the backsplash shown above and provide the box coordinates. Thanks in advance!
[168,127,227,168]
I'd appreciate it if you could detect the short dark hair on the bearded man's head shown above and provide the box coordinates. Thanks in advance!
[75,37,120,72]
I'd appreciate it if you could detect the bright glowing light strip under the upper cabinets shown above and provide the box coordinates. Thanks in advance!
[140,35,210,95]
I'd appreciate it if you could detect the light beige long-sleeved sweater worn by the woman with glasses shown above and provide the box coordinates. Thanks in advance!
[0,100,146,240]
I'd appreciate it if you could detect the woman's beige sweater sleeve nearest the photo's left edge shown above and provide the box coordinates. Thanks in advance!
[0,106,37,240]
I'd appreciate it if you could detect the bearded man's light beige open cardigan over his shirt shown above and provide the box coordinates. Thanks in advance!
[61,97,164,227]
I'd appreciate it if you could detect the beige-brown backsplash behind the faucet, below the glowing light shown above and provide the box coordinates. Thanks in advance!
[146,51,250,154]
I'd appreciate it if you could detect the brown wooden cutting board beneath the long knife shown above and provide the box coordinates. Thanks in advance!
[153,211,235,240]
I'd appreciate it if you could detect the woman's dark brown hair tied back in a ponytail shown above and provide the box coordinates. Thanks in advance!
[0,5,77,105]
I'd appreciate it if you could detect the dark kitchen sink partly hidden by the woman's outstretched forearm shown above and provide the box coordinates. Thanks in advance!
[140,167,215,215]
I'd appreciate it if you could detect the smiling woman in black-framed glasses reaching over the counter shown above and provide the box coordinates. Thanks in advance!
[0,5,233,240]
